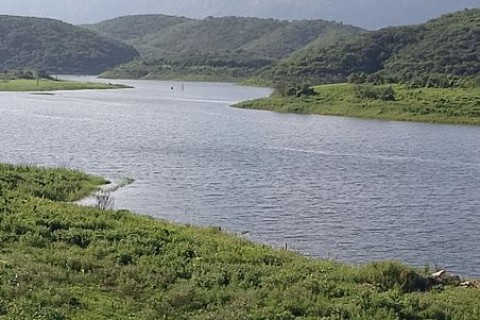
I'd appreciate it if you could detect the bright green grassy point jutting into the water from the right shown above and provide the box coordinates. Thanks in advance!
[236,84,480,125]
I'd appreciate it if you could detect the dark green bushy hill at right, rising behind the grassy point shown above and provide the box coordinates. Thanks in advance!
[265,9,480,83]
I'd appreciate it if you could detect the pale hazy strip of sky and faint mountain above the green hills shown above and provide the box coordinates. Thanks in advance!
[0,0,480,29]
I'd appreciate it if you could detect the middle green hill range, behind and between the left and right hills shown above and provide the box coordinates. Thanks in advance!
[86,15,362,79]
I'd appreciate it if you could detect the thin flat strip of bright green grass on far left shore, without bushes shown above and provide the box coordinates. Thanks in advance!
[0,79,129,91]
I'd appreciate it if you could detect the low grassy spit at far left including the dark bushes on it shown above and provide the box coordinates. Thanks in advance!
[0,68,131,92]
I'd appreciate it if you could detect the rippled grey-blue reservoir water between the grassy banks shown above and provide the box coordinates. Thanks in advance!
[0,81,480,277]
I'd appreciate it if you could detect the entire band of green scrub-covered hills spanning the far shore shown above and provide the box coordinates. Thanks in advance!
[0,9,480,83]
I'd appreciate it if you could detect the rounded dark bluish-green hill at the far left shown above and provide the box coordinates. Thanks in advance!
[0,16,138,74]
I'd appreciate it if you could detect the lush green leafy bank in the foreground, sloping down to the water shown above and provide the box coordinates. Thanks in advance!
[0,165,480,320]
